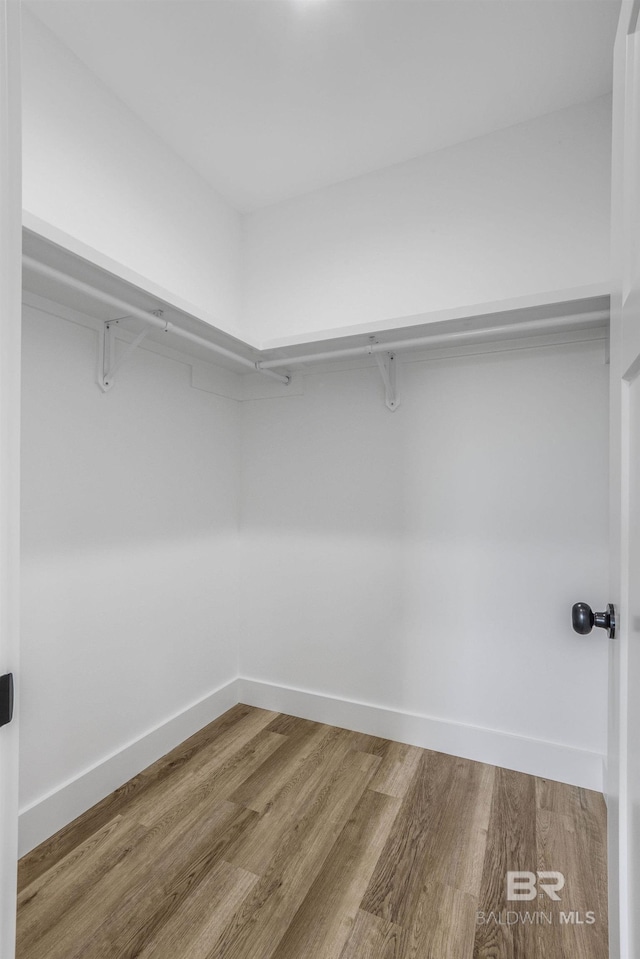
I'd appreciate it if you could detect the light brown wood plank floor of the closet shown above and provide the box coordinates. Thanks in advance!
[17,705,607,959]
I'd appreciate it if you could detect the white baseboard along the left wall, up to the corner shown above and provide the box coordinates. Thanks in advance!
[18,680,240,856]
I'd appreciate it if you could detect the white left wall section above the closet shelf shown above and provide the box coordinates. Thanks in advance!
[23,10,241,333]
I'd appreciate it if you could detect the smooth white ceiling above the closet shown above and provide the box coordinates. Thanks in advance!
[26,0,619,211]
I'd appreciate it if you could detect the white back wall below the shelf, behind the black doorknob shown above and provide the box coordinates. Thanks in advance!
[240,342,608,768]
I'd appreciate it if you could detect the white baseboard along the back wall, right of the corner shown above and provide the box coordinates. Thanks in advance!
[238,677,603,792]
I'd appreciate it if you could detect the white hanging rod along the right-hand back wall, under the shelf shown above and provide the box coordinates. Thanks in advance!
[256,310,609,373]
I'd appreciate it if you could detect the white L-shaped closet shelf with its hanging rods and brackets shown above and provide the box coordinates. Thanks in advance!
[23,223,609,402]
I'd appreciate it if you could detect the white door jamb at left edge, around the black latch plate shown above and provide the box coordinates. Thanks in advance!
[0,0,22,959]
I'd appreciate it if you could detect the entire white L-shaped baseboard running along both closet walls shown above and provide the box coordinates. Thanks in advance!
[19,677,604,856]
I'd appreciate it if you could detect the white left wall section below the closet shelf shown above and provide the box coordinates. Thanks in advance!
[20,307,239,824]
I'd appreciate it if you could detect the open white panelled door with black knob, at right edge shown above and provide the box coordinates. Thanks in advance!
[607,0,640,959]
